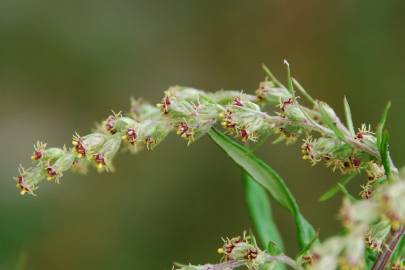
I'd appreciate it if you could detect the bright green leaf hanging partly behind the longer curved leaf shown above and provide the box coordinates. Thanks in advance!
[243,172,283,249]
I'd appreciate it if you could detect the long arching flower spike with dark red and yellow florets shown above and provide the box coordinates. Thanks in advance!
[13,68,381,197]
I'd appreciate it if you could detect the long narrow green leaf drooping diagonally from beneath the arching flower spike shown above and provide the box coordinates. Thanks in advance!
[208,128,315,248]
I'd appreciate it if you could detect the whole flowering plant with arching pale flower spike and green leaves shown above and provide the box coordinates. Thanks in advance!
[16,62,405,270]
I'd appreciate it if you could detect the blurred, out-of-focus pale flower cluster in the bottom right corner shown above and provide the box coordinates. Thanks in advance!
[308,179,405,269]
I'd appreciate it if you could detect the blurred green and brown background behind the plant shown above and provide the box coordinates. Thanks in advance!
[0,0,405,270]
